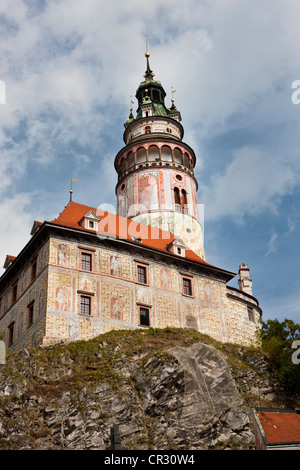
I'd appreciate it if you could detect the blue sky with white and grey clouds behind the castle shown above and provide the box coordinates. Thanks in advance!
[0,0,300,322]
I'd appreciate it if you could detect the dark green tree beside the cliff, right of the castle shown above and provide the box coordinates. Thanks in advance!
[261,319,300,395]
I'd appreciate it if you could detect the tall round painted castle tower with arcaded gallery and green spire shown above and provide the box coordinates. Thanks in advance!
[115,52,205,260]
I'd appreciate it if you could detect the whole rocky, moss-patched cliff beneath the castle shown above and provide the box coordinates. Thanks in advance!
[0,328,293,450]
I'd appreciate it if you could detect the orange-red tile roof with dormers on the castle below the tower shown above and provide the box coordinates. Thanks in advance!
[49,201,224,274]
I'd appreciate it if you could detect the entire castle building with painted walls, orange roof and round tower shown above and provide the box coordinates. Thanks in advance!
[0,53,262,350]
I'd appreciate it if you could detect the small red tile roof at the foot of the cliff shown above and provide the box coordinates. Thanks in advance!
[256,411,300,444]
